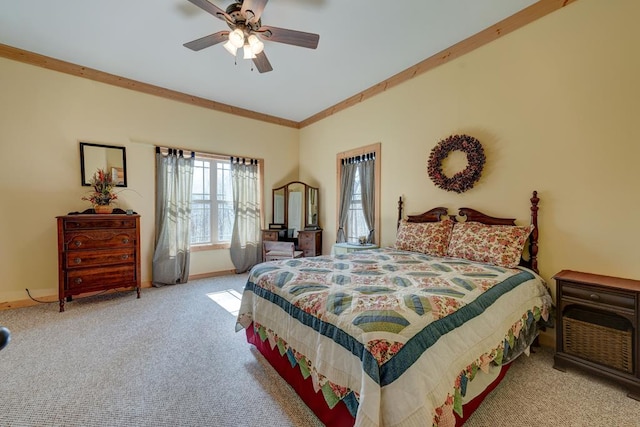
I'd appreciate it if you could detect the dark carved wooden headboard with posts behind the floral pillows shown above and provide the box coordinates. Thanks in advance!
[397,191,540,273]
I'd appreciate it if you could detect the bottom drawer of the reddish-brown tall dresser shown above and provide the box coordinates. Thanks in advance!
[65,264,137,292]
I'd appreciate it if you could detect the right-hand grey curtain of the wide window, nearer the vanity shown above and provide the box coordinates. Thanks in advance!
[231,157,262,273]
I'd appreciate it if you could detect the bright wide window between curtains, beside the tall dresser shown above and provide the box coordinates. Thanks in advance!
[191,155,234,245]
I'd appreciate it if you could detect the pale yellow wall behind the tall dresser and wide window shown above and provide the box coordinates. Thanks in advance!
[0,59,298,303]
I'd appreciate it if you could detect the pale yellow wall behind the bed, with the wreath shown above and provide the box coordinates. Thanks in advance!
[300,0,640,290]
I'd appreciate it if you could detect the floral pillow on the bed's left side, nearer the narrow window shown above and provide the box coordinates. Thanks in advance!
[395,219,453,256]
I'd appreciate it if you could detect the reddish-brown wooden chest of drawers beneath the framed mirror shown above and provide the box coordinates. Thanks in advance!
[57,214,140,312]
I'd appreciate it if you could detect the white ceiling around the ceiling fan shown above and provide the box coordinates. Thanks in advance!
[0,0,535,121]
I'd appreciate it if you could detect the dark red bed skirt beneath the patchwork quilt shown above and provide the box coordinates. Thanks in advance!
[245,325,511,427]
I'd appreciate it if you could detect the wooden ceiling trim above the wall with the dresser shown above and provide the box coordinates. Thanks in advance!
[0,44,299,129]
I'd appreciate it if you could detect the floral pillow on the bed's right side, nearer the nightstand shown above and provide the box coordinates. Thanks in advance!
[447,222,533,268]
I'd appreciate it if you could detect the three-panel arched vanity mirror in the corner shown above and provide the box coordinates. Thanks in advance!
[272,181,320,237]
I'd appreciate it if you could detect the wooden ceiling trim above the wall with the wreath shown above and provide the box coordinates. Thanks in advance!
[298,0,577,129]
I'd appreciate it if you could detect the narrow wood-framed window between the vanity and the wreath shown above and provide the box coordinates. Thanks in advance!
[336,143,381,244]
